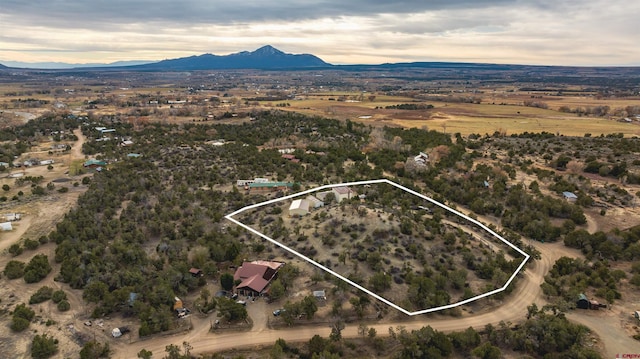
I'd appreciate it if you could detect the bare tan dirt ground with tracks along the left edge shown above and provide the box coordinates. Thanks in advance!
[0,131,90,358]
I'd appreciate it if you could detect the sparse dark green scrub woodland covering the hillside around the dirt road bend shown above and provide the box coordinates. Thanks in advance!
[0,111,640,358]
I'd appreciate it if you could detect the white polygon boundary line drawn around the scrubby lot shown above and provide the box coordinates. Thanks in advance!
[225,178,530,316]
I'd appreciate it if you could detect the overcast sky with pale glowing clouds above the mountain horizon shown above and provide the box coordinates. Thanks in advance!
[0,0,640,65]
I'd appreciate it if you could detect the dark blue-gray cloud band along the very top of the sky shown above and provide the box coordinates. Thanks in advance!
[0,0,518,28]
